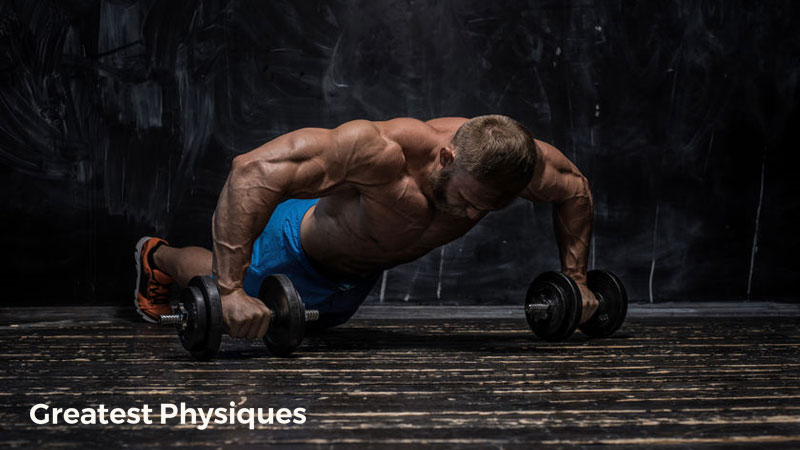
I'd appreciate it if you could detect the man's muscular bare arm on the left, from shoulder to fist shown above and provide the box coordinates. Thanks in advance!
[212,120,384,339]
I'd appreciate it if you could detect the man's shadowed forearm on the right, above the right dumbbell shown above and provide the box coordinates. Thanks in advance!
[553,178,594,282]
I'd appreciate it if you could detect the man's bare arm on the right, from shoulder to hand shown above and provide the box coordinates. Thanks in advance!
[521,140,597,322]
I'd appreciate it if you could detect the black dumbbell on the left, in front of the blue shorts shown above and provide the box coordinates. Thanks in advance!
[159,274,319,361]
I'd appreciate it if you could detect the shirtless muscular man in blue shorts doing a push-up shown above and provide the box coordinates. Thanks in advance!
[135,115,598,339]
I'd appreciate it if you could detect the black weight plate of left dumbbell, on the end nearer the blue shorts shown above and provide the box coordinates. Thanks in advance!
[258,274,306,357]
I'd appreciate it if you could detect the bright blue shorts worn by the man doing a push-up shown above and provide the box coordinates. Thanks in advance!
[244,199,380,327]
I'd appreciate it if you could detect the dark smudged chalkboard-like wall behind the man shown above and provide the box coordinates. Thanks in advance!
[0,0,800,304]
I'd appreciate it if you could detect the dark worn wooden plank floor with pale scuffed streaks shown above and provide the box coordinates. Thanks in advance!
[0,310,800,449]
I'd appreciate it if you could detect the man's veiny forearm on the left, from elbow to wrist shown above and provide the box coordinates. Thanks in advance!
[212,159,281,295]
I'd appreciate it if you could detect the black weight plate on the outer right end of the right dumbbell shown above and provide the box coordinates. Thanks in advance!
[580,270,628,337]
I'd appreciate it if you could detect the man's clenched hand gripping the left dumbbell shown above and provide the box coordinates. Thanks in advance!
[221,289,272,339]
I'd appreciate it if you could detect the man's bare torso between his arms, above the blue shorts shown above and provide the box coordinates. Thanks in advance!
[301,118,480,276]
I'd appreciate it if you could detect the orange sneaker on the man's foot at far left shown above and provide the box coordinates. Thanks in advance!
[133,236,173,323]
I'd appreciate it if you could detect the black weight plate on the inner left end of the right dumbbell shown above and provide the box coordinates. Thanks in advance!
[525,272,581,341]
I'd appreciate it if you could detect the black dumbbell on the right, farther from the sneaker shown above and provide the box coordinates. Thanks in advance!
[525,270,628,341]
